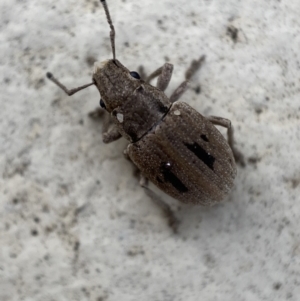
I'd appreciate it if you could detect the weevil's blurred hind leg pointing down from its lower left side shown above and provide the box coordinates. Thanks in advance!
[140,174,179,233]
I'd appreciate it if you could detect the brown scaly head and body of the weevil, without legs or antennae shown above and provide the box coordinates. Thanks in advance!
[93,60,236,205]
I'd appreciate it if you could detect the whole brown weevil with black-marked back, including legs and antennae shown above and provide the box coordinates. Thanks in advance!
[47,0,243,229]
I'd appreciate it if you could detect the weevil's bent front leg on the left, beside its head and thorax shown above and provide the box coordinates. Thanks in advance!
[89,108,122,143]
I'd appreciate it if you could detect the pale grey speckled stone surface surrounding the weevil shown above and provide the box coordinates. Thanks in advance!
[0,0,300,301]
